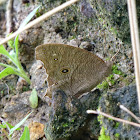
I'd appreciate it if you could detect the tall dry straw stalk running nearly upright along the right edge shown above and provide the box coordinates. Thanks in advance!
[127,0,140,113]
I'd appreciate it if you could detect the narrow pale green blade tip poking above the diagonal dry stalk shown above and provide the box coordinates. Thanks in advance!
[19,6,40,29]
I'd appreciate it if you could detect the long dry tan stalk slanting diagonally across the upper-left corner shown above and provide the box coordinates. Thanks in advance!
[0,0,78,45]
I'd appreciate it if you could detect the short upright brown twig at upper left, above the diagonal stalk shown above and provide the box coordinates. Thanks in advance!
[6,0,13,35]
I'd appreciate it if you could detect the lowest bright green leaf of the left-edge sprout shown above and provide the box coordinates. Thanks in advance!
[0,67,19,79]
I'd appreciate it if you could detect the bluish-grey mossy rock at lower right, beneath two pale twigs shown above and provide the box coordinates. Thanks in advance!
[100,85,140,140]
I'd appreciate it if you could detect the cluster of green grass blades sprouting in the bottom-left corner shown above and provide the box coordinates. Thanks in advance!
[0,112,32,140]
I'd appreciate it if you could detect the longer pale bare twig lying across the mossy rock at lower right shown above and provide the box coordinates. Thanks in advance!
[87,110,140,127]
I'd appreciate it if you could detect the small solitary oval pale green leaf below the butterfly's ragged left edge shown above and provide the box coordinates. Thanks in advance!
[29,89,38,108]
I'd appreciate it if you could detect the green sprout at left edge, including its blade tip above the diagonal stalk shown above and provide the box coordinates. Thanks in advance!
[0,6,40,84]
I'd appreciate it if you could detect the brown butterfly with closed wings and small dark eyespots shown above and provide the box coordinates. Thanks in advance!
[36,44,112,97]
